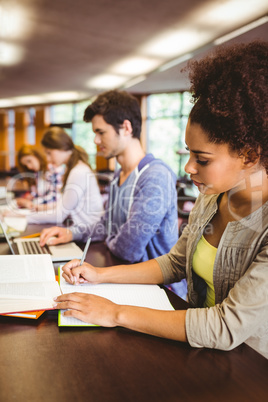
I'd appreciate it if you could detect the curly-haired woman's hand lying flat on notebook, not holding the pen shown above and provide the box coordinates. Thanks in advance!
[55,293,120,327]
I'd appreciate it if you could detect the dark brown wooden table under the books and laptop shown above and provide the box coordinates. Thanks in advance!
[0,227,268,402]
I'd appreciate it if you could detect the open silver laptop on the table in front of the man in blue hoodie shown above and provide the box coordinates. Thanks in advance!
[0,219,83,262]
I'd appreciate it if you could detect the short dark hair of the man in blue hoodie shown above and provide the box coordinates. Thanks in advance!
[84,90,141,139]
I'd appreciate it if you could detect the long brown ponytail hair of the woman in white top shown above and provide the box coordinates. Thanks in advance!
[41,126,91,189]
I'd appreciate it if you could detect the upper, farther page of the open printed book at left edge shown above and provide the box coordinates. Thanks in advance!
[0,255,55,283]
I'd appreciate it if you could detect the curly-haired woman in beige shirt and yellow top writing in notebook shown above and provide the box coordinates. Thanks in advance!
[55,42,268,358]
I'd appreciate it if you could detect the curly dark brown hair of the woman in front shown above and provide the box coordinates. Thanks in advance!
[187,41,268,174]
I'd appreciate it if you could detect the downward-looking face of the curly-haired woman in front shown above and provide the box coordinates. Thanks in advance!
[185,120,245,194]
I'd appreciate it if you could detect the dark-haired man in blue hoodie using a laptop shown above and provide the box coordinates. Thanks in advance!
[40,91,178,263]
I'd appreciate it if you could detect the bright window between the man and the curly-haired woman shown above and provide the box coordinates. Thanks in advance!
[147,92,192,177]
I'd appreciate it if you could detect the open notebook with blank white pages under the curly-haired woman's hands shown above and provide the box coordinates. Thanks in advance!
[58,267,174,326]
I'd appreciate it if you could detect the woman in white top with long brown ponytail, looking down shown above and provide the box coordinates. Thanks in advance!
[24,127,103,225]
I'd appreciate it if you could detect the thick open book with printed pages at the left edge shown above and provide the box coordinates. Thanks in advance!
[0,254,61,318]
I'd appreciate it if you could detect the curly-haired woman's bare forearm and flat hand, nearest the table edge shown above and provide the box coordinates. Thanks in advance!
[54,292,187,342]
